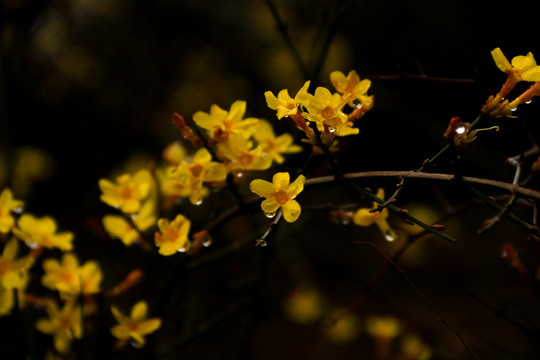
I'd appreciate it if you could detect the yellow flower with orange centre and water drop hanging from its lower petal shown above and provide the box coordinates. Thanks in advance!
[169,148,227,205]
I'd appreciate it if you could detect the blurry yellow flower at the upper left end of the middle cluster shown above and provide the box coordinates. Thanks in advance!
[98,169,153,214]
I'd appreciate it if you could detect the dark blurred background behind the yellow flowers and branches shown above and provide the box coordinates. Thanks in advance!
[0,0,540,359]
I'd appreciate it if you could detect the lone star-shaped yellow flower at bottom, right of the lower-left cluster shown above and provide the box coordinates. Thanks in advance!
[111,301,161,347]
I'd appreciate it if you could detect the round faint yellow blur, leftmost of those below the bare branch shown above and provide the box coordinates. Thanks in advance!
[283,286,324,324]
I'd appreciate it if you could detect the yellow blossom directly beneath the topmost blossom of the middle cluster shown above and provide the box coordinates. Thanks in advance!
[218,135,272,173]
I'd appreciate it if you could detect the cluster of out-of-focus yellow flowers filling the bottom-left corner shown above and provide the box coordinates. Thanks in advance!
[0,188,160,354]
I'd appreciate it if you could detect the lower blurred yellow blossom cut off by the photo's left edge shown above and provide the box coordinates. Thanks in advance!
[0,239,34,316]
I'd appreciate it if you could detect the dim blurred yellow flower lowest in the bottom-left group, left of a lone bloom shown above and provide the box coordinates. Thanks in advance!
[36,299,82,354]
